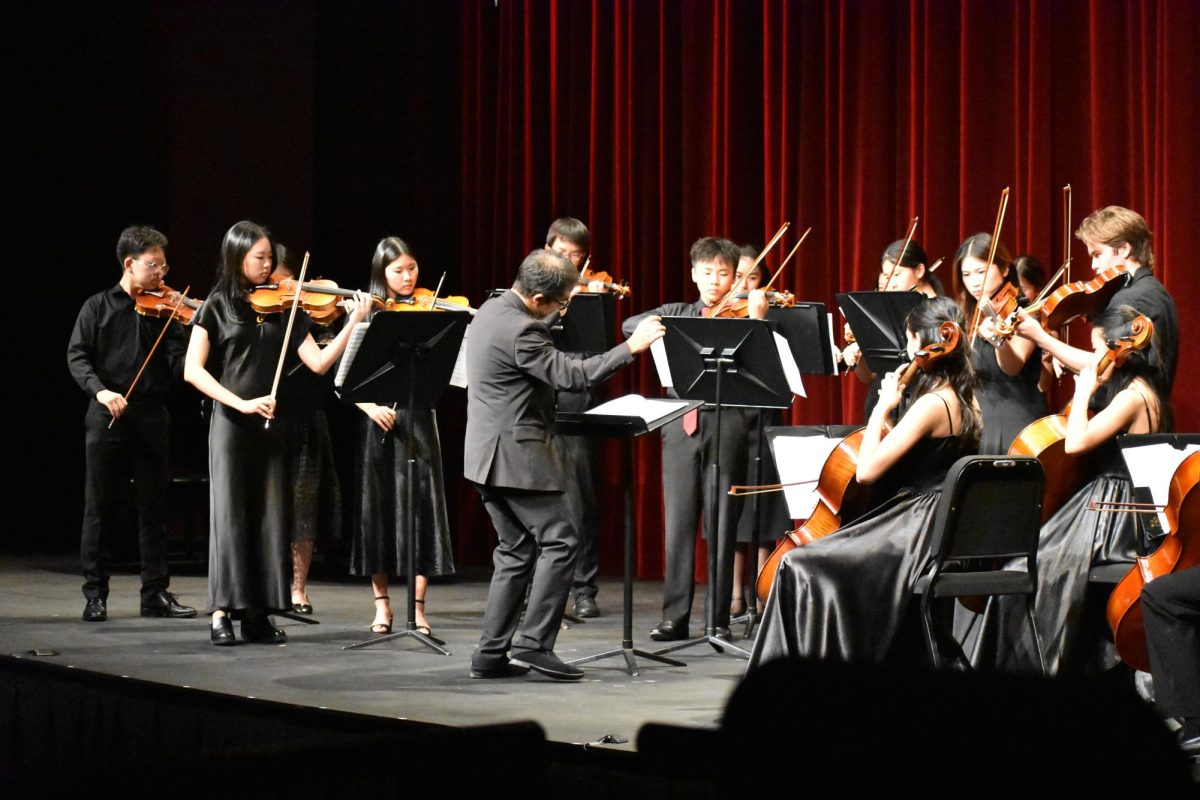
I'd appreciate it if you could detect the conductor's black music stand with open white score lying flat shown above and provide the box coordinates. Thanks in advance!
[554,398,703,675]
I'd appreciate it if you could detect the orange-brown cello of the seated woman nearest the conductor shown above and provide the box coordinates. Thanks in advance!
[755,321,962,602]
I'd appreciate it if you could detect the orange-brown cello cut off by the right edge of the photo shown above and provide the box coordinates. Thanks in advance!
[1106,452,1200,672]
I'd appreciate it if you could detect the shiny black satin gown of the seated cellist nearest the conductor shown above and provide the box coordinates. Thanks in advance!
[749,437,970,669]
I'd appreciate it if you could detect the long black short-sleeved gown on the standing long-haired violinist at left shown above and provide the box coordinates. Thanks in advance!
[196,295,311,613]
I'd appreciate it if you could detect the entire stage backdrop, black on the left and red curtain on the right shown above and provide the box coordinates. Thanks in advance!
[7,0,1200,592]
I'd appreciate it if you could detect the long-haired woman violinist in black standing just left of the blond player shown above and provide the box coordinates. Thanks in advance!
[954,234,1046,456]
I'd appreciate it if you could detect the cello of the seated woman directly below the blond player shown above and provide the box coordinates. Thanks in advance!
[1008,314,1154,522]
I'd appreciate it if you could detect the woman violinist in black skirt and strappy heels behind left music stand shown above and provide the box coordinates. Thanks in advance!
[350,236,455,634]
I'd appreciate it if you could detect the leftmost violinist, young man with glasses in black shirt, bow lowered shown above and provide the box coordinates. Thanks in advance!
[67,225,196,622]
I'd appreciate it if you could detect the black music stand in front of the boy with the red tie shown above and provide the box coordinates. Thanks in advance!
[655,317,792,658]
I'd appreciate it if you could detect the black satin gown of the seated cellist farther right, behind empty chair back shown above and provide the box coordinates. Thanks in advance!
[968,440,1148,675]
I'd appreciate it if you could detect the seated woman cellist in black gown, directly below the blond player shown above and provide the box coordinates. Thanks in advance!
[971,306,1171,674]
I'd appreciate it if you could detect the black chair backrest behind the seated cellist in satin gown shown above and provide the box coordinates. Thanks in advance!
[932,456,1045,565]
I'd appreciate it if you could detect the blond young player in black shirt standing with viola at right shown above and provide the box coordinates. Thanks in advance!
[1016,205,1180,398]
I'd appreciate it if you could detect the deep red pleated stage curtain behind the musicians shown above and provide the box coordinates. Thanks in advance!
[460,0,1200,578]
